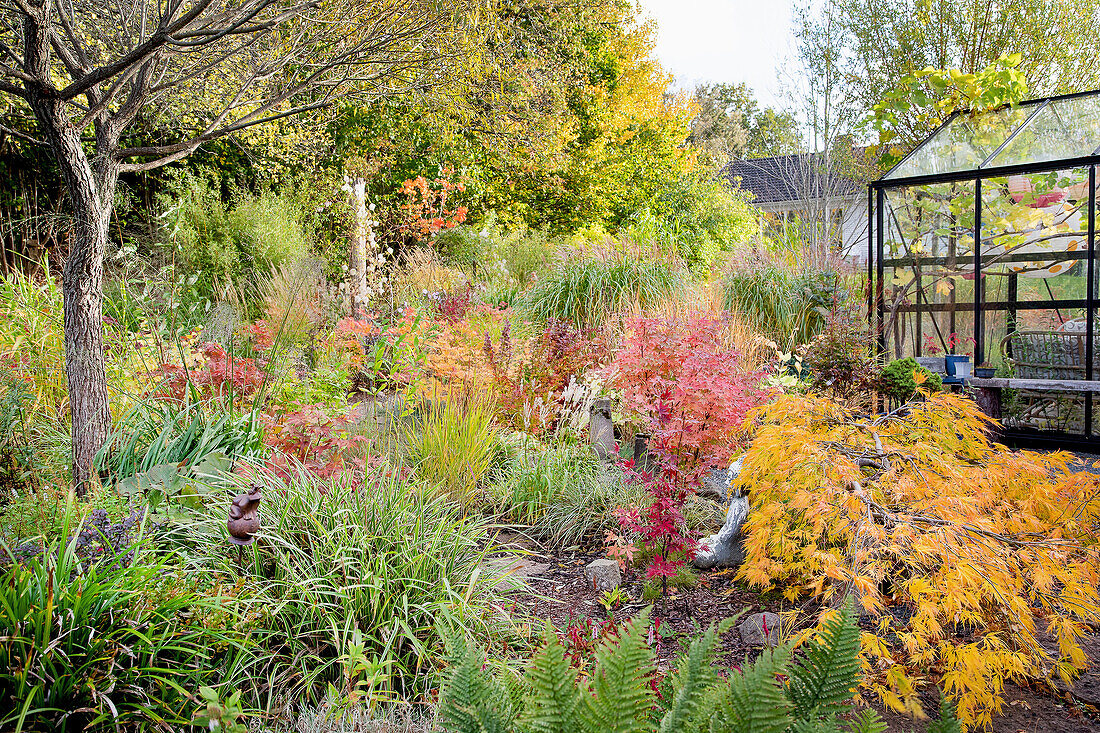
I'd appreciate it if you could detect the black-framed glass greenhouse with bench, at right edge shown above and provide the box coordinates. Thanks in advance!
[868,91,1100,448]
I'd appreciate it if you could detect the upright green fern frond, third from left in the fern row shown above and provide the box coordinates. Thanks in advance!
[580,613,655,733]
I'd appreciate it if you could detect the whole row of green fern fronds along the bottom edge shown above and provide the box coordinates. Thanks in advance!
[439,601,932,733]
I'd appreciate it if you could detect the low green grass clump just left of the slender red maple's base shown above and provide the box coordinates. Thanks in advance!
[490,445,640,547]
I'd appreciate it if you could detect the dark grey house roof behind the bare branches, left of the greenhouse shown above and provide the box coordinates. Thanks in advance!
[718,153,859,204]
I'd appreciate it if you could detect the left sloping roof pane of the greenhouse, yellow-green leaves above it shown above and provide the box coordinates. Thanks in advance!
[886,105,1035,178]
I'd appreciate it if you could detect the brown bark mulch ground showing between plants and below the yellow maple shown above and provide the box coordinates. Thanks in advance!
[490,530,1100,733]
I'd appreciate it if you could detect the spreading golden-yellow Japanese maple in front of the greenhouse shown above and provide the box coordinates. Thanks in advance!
[740,395,1100,727]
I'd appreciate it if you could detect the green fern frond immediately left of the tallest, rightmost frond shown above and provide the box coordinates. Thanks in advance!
[711,644,793,733]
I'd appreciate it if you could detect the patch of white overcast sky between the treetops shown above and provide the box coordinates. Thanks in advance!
[640,0,793,106]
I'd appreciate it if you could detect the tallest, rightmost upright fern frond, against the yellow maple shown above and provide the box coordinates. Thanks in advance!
[788,597,859,720]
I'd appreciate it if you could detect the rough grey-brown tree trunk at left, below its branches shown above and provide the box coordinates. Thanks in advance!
[29,89,119,494]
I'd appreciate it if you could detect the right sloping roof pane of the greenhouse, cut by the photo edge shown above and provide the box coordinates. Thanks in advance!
[989,95,1100,166]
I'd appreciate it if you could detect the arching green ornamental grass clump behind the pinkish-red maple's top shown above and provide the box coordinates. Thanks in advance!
[521,255,682,328]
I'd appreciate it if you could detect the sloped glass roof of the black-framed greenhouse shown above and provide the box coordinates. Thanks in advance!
[871,90,1100,188]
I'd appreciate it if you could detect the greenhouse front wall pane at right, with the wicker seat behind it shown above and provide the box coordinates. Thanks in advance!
[981,168,1100,435]
